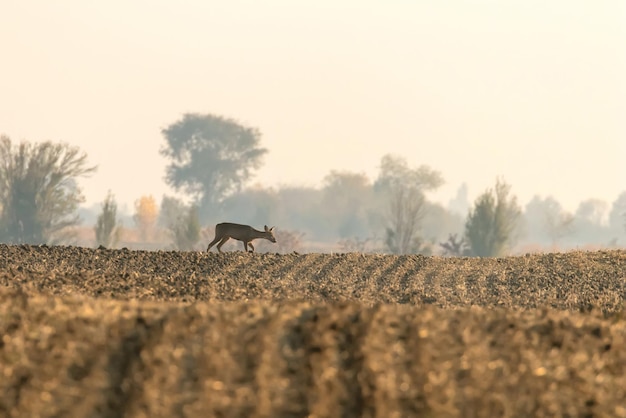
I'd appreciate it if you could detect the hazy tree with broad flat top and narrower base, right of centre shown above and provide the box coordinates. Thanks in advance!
[374,155,444,254]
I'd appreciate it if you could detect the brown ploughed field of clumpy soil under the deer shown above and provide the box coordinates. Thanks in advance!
[0,245,626,417]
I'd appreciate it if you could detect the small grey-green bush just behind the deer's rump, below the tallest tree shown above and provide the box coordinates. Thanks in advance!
[160,196,201,251]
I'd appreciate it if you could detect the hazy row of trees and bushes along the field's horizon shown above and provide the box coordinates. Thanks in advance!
[0,114,626,257]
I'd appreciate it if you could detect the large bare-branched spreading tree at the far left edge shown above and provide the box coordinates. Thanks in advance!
[0,136,96,244]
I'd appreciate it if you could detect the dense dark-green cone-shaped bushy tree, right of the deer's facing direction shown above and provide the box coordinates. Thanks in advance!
[465,179,521,257]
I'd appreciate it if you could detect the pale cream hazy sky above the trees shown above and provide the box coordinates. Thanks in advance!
[0,0,626,216]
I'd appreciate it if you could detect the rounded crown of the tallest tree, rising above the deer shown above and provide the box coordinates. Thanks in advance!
[161,113,267,220]
